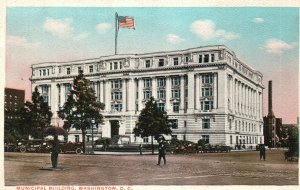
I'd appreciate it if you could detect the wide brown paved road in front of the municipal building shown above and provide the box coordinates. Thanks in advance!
[4,150,298,186]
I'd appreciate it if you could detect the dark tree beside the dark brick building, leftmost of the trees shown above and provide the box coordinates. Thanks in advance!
[20,87,53,138]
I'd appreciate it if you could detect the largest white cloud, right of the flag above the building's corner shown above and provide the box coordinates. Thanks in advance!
[190,20,239,41]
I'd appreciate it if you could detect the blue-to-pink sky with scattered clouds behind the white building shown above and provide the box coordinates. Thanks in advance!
[5,7,299,123]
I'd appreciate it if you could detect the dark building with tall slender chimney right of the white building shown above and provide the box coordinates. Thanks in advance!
[264,81,282,147]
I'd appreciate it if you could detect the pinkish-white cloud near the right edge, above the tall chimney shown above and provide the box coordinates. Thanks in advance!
[264,38,297,54]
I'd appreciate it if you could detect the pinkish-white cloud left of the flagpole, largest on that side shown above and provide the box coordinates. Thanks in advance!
[44,18,73,38]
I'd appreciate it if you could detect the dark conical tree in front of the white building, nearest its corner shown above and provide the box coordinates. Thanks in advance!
[133,97,172,154]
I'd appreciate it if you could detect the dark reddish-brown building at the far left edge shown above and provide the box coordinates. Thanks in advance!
[4,88,25,121]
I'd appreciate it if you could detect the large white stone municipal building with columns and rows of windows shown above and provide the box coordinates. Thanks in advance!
[31,45,264,148]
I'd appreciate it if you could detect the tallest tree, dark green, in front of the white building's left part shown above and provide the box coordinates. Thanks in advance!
[58,71,105,153]
